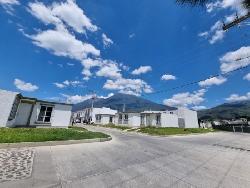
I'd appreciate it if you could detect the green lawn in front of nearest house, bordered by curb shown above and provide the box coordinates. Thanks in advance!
[0,127,109,143]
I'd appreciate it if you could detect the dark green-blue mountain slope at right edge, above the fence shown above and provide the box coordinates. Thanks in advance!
[198,100,250,119]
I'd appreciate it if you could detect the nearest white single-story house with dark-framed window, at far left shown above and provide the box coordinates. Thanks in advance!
[0,90,72,127]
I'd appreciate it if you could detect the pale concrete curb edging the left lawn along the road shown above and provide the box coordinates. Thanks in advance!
[0,137,112,149]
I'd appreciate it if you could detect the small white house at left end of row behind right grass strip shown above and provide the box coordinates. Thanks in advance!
[115,112,141,127]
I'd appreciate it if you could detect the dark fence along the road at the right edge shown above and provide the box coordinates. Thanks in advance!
[213,124,250,133]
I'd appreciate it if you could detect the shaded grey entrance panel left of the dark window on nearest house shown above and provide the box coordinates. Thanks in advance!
[15,103,32,126]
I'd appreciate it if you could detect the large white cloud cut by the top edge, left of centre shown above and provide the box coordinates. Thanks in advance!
[29,0,98,33]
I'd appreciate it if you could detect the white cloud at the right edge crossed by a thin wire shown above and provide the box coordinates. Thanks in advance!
[220,46,250,73]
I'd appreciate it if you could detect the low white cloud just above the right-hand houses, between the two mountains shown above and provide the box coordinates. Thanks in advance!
[163,89,206,107]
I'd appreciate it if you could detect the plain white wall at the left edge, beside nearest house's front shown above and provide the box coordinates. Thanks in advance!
[0,89,18,127]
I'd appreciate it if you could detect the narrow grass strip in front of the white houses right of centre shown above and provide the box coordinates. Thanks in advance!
[138,127,215,136]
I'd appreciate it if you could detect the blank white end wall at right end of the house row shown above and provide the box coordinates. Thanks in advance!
[178,108,199,128]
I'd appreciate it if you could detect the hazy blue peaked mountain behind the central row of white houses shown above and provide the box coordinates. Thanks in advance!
[73,93,175,112]
